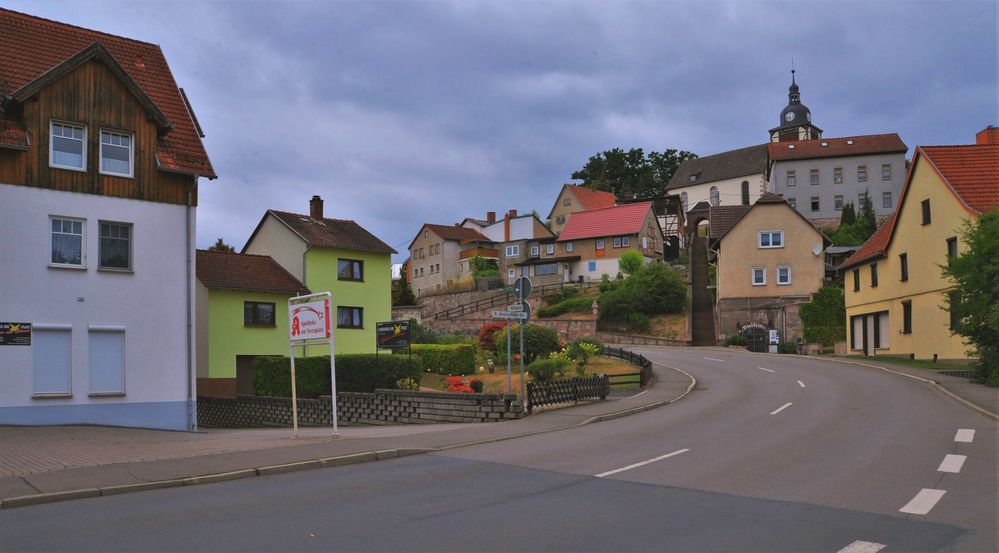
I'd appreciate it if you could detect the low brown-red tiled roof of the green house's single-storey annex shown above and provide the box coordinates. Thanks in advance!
[195,250,309,294]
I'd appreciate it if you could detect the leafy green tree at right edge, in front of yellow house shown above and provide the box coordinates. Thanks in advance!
[942,208,999,387]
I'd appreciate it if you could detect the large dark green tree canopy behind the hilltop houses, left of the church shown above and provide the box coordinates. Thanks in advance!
[572,148,697,200]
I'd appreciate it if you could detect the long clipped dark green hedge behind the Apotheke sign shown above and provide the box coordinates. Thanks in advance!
[253,354,422,398]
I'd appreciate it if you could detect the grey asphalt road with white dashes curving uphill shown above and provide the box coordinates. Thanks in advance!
[0,348,999,552]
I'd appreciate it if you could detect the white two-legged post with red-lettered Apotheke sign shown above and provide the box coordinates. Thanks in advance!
[288,292,340,438]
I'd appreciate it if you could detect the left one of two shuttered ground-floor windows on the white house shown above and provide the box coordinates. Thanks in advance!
[31,324,73,397]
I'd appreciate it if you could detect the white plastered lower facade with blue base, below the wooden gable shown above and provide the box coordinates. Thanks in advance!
[0,184,197,430]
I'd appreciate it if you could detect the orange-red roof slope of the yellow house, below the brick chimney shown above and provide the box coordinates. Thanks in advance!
[916,144,999,214]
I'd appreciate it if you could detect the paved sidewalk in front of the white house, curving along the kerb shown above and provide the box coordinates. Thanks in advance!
[0,366,694,509]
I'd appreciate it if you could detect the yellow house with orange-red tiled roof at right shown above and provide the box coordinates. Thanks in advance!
[842,132,999,360]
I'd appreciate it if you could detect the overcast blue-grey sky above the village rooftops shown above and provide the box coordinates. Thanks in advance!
[4,0,999,261]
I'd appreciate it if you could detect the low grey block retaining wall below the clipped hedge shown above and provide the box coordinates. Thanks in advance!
[198,390,524,428]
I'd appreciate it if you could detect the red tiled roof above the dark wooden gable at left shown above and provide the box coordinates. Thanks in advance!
[0,8,216,178]
